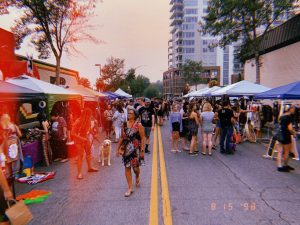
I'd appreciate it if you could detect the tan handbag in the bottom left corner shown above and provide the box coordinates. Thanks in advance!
[5,200,33,225]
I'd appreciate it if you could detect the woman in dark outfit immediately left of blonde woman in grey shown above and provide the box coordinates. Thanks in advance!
[188,103,199,156]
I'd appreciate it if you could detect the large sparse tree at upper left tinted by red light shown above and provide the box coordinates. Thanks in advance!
[8,0,97,84]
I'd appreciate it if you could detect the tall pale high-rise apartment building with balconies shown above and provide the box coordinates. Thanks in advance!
[164,0,242,97]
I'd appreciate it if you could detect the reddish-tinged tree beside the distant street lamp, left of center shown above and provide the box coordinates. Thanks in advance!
[96,57,125,91]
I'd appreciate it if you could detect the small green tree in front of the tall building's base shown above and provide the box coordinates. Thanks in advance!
[181,60,207,90]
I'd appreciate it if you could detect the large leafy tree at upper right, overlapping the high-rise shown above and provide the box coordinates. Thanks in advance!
[200,0,297,84]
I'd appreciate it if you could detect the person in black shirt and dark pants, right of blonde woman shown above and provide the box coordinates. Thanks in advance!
[218,100,233,154]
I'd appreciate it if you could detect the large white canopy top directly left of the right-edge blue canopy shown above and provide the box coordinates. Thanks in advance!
[211,80,270,97]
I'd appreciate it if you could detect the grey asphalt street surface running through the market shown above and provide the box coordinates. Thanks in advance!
[17,121,300,225]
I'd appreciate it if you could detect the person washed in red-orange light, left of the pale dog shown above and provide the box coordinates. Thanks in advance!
[72,108,98,179]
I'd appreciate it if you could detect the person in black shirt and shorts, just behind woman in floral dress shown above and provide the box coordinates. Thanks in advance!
[139,98,155,154]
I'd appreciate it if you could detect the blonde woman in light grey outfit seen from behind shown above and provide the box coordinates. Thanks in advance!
[200,102,215,156]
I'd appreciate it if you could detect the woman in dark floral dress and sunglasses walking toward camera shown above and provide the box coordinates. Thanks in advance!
[117,107,145,197]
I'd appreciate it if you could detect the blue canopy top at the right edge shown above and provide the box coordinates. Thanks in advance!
[254,81,300,100]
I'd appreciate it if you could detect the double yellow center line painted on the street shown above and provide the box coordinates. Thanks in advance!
[149,126,173,225]
